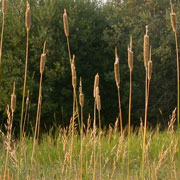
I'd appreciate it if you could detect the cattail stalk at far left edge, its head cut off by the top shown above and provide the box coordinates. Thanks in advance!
[0,0,7,74]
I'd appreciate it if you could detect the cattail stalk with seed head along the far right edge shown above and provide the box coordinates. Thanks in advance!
[170,0,180,127]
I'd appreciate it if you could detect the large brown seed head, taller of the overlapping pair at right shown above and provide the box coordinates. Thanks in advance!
[144,26,149,68]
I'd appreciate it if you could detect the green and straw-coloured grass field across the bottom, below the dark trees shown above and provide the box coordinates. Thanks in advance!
[0,119,180,180]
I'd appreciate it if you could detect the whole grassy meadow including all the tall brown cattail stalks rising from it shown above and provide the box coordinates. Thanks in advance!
[0,0,180,180]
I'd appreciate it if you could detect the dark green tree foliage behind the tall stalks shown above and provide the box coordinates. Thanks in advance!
[0,0,180,134]
